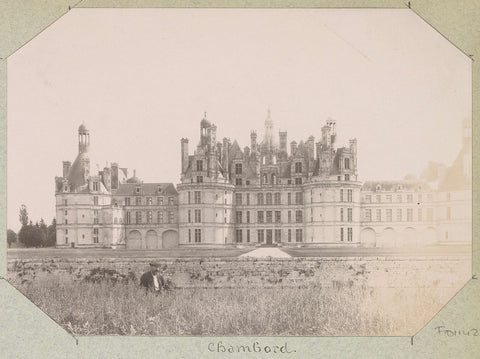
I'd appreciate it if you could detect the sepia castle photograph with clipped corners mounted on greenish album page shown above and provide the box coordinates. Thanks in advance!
[7,8,472,340]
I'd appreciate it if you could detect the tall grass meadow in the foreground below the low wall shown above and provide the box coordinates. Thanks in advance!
[17,278,452,336]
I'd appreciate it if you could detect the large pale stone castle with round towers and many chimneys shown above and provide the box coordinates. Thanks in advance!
[55,111,472,249]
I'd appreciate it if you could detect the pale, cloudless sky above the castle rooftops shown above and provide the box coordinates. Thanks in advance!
[7,9,472,230]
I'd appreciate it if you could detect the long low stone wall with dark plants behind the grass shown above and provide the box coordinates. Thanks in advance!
[8,256,471,288]
